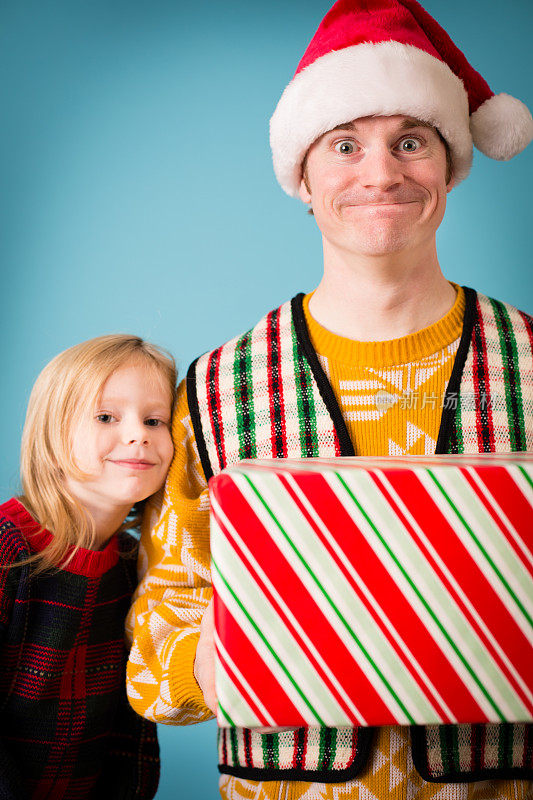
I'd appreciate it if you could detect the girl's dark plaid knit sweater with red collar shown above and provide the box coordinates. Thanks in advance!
[0,499,159,800]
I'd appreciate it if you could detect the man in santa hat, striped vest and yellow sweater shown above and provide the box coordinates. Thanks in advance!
[128,0,533,800]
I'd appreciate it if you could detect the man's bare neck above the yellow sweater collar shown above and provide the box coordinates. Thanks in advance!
[309,242,456,341]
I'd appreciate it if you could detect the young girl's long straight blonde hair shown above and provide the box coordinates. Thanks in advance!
[19,334,177,572]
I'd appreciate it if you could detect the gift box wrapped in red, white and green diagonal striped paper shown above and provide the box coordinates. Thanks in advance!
[210,454,533,727]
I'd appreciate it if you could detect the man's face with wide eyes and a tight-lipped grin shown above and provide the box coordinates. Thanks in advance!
[300,115,453,256]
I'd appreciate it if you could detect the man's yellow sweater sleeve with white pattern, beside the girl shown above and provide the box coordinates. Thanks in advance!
[126,381,212,725]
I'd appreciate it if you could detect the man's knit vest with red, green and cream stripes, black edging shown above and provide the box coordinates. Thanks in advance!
[187,288,533,782]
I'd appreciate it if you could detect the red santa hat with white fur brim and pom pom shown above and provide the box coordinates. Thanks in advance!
[270,0,533,196]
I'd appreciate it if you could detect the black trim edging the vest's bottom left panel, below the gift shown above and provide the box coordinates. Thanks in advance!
[218,728,376,783]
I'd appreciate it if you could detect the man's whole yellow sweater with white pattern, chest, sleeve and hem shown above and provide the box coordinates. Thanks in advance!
[127,287,533,800]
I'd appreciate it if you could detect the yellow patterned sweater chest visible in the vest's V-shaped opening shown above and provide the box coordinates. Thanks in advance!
[303,287,465,456]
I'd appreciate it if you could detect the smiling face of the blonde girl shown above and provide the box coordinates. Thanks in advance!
[67,364,173,520]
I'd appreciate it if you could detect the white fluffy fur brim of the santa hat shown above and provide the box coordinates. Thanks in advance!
[270,41,472,197]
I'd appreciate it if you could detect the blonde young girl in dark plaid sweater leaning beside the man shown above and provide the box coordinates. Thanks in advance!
[0,335,176,800]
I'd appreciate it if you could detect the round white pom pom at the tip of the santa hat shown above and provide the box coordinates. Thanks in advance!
[470,94,533,161]
